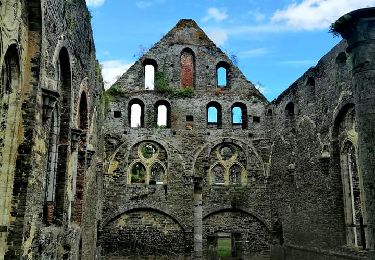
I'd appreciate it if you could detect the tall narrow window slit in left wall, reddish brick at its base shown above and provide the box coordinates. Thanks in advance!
[43,107,59,224]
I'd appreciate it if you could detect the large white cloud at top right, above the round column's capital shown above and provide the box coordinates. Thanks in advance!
[271,0,375,30]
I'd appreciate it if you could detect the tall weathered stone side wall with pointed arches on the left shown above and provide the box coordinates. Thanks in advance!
[0,0,103,259]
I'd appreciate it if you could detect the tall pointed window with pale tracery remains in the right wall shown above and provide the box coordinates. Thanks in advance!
[332,103,367,249]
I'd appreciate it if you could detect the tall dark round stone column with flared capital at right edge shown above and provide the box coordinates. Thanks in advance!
[332,8,375,259]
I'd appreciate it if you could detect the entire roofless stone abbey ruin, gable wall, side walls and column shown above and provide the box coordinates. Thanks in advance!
[0,0,375,260]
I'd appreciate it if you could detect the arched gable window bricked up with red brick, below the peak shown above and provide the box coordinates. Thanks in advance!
[180,48,195,88]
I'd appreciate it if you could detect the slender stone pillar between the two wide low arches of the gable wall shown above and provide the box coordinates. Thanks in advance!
[194,178,203,259]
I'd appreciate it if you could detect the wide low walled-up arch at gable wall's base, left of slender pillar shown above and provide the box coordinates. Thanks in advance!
[99,208,185,259]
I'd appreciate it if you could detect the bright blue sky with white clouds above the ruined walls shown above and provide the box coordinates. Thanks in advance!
[86,0,375,101]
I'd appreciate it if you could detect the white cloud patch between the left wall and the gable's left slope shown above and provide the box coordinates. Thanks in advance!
[101,60,134,89]
